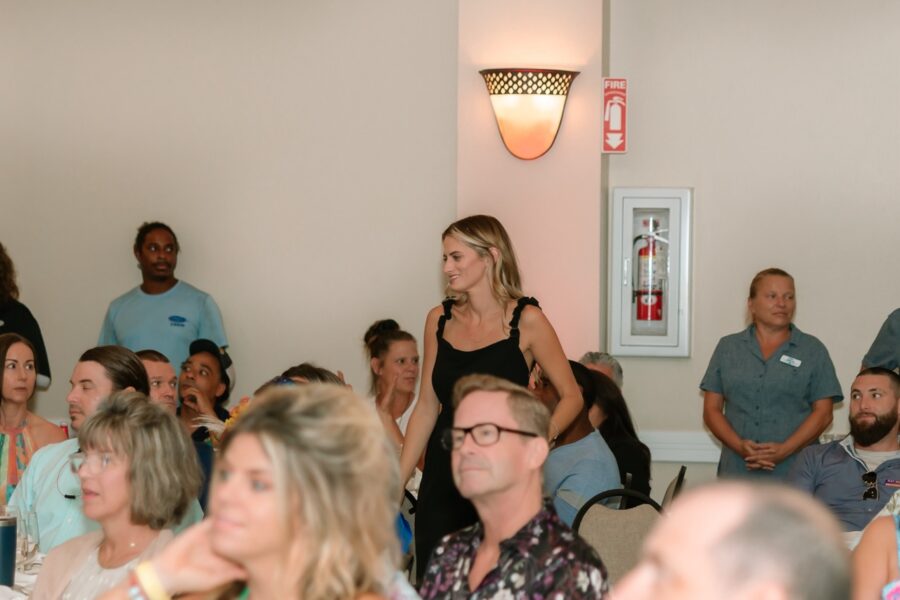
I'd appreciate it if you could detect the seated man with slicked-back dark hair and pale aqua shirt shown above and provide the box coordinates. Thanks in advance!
[9,346,203,554]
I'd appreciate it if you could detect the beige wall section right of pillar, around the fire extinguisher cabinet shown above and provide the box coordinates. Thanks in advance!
[608,0,900,454]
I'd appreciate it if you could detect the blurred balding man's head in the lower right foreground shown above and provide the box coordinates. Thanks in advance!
[614,483,850,600]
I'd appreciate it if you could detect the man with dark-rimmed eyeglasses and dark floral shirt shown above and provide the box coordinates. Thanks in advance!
[419,375,608,600]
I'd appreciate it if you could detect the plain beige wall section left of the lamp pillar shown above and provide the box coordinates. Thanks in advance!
[0,0,457,417]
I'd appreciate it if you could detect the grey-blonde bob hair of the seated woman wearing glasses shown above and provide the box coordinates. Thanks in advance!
[78,392,201,530]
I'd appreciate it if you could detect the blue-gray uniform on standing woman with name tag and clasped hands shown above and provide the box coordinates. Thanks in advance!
[700,325,844,479]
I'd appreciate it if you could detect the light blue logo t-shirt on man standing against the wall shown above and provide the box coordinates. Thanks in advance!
[98,281,228,373]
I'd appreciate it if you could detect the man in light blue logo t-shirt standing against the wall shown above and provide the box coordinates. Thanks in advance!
[98,221,228,373]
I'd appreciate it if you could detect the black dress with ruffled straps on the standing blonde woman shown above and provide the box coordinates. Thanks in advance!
[416,298,538,581]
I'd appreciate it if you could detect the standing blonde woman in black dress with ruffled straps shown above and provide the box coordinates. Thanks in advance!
[400,215,581,577]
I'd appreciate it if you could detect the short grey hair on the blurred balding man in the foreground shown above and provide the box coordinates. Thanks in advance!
[710,485,850,600]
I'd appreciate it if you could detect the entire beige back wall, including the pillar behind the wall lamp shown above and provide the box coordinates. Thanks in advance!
[0,0,900,466]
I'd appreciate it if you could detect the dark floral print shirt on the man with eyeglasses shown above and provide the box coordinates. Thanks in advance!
[419,500,609,600]
